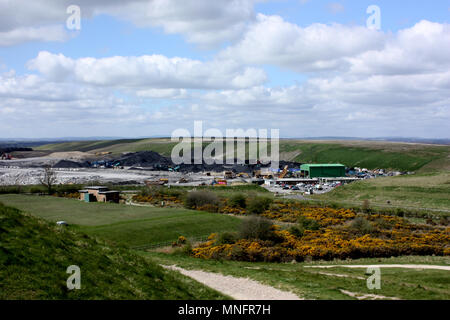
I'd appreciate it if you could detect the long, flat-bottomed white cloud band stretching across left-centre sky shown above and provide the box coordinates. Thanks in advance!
[28,51,266,89]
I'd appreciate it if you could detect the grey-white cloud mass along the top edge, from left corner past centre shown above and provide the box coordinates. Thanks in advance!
[0,0,258,47]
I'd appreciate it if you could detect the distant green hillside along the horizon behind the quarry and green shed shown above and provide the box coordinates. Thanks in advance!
[36,138,450,171]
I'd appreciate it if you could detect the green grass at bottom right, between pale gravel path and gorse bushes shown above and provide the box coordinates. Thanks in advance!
[142,252,450,300]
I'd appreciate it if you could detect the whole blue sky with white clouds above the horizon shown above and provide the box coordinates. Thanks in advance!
[0,0,450,138]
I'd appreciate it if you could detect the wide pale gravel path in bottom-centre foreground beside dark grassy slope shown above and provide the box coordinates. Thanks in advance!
[163,266,302,300]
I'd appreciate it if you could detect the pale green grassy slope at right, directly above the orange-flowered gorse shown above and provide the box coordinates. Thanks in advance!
[313,171,450,210]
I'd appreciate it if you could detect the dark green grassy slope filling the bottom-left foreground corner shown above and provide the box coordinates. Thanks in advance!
[0,204,224,299]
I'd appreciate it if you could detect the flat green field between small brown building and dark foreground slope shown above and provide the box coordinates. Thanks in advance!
[0,194,240,246]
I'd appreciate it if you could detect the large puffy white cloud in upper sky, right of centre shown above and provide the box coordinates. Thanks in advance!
[221,14,385,72]
